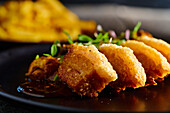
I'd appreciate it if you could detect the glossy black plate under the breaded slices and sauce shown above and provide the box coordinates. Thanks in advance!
[0,44,170,112]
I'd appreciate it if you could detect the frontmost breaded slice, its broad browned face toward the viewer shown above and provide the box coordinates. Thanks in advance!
[58,45,117,97]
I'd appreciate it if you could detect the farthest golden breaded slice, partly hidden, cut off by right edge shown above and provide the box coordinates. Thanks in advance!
[137,35,170,63]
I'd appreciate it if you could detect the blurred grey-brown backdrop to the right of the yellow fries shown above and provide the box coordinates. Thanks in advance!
[1,0,170,41]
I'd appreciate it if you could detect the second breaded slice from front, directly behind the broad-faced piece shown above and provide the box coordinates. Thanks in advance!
[99,44,146,91]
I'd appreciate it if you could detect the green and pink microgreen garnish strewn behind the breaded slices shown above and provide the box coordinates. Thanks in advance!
[35,22,141,62]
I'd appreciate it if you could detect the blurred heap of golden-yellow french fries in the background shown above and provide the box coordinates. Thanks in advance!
[0,0,96,43]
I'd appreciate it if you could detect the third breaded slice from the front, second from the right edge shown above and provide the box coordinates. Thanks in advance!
[121,40,170,85]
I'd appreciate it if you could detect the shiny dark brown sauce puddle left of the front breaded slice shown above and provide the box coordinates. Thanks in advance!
[17,78,75,98]
